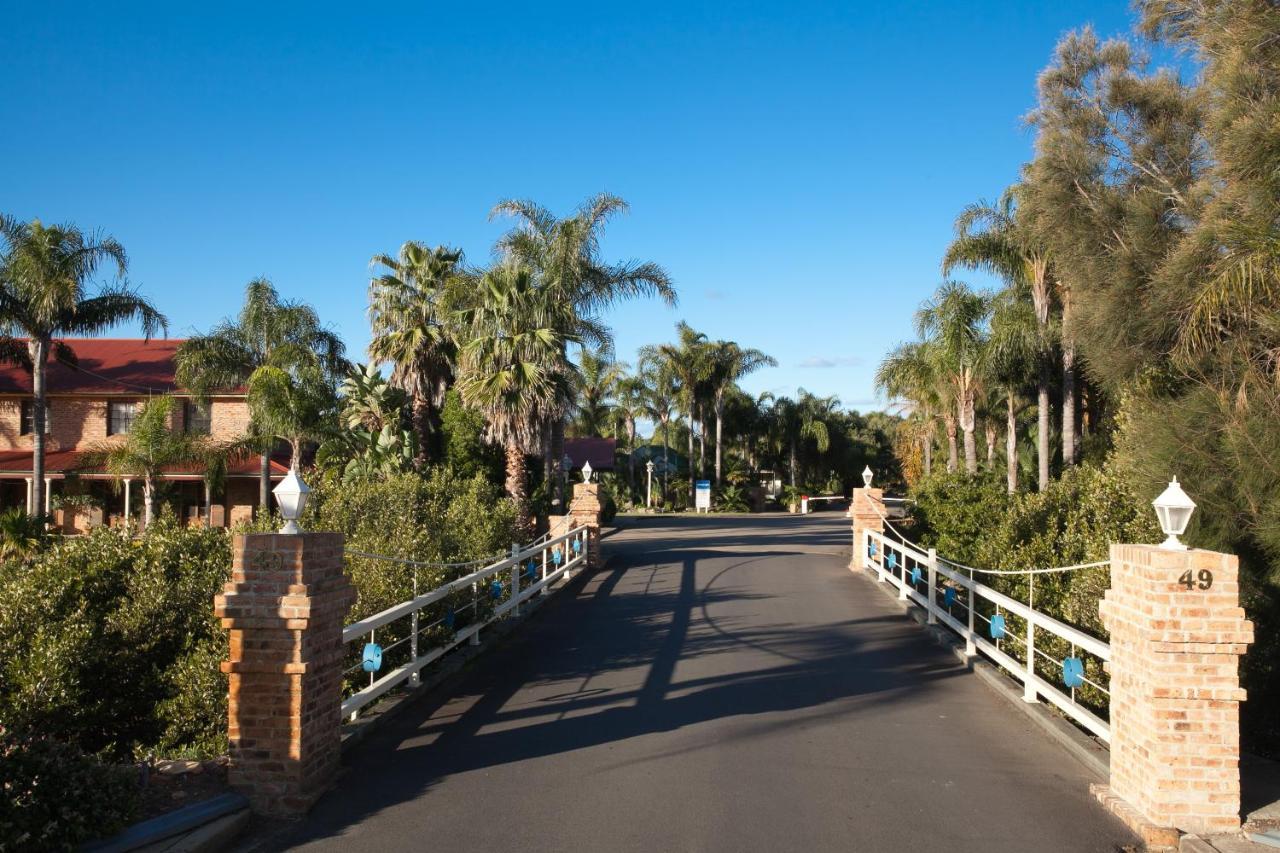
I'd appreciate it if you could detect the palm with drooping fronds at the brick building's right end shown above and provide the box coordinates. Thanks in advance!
[174,278,351,511]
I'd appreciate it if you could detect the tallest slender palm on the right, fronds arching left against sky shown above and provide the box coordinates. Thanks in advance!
[942,187,1054,492]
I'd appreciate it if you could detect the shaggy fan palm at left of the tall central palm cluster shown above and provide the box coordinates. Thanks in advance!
[369,240,465,467]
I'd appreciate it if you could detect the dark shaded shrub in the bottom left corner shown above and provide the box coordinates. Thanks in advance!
[0,726,138,852]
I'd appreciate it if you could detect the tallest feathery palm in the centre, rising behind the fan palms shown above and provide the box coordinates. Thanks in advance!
[490,192,676,512]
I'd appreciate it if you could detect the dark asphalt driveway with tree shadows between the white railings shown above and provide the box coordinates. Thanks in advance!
[264,512,1134,853]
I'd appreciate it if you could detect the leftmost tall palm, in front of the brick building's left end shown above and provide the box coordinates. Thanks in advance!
[0,214,168,508]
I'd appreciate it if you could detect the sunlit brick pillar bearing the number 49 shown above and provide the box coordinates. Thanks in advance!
[1098,544,1253,834]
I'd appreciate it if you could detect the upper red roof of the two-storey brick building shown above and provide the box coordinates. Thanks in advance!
[0,338,192,394]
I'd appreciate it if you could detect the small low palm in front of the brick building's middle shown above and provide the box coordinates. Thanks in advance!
[79,394,230,526]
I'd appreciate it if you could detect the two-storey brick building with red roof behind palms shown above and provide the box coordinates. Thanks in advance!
[0,338,288,533]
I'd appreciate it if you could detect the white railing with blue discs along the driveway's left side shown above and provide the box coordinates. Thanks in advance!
[342,525,588,719]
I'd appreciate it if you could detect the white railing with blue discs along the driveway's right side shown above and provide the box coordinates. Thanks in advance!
[856,529,1111,743]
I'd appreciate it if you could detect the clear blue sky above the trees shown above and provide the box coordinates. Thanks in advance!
[0,0,1130,409]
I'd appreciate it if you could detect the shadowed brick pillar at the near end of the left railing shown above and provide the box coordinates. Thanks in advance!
[214,533,356,817]
